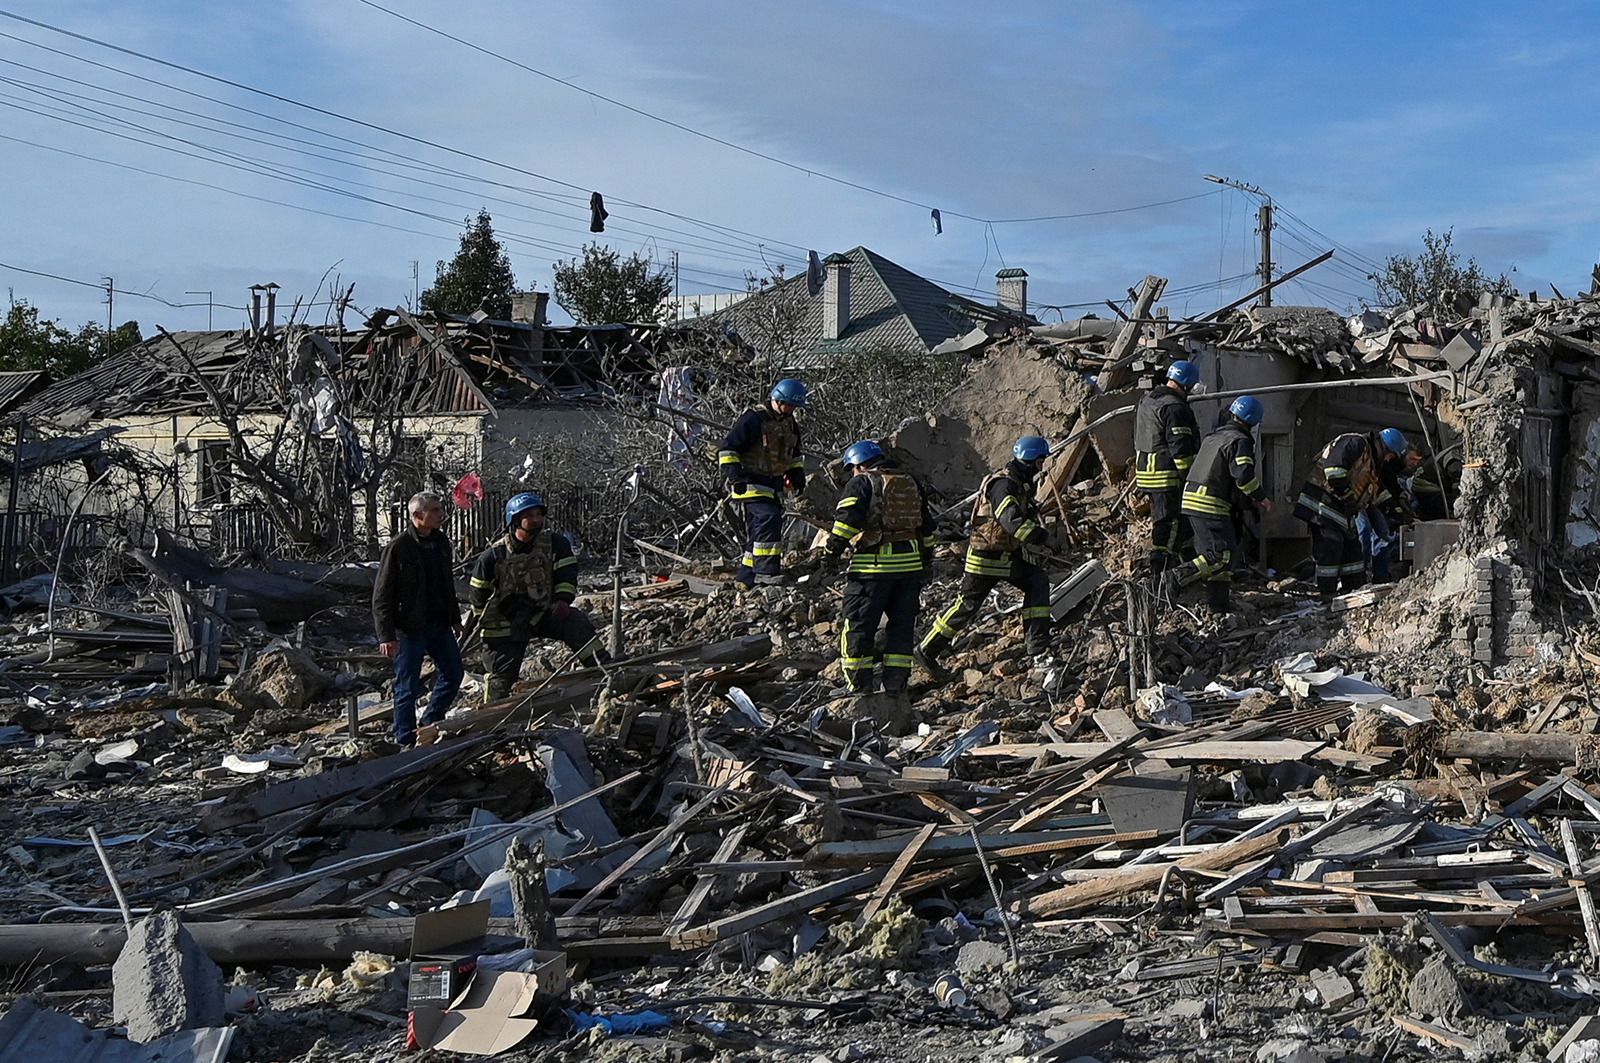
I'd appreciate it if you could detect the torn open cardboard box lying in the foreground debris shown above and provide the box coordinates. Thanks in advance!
[406,901,570,1055]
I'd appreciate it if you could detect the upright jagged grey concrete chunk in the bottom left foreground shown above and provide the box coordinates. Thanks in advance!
[110,909,227,1042]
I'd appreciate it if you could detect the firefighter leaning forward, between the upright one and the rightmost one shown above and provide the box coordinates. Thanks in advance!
[1182,395,1272,616]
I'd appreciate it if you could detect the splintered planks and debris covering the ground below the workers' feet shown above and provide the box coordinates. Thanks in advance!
[0,521,1600,1060]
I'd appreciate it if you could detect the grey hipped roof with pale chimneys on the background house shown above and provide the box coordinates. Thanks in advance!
[701,247,1034,371]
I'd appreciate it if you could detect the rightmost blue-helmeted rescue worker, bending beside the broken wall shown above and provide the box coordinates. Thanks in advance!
[1294,427,1406,602]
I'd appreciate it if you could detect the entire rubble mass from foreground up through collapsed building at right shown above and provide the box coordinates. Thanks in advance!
[15,279,1600,1063]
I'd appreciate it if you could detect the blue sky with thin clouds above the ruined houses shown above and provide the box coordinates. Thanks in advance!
[0,0,1600,331]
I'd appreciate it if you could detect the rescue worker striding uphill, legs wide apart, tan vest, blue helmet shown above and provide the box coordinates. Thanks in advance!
[915,435,1053,679]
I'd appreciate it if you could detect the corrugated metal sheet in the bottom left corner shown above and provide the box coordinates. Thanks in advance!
[0,997,234,1063]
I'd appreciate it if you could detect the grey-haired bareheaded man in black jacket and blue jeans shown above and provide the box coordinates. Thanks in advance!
[373,491,462,746]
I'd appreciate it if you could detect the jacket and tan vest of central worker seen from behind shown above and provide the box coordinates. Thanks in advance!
[826,463,933,578]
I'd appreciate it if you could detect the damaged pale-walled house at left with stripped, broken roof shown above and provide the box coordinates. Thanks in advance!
[10,298,651,551]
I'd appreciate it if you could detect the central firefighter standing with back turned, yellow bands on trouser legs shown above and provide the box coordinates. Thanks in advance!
[824,440,933,695]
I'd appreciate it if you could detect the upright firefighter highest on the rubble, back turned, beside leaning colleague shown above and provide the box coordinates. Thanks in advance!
[1133,362,1200,581]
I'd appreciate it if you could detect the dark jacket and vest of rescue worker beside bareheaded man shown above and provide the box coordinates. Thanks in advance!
[472,528,578,639]
